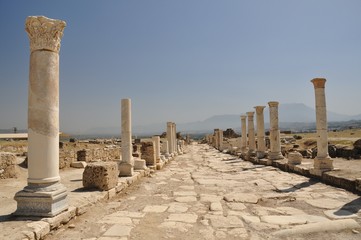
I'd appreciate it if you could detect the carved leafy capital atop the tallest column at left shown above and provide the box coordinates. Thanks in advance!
[25,16,66,53]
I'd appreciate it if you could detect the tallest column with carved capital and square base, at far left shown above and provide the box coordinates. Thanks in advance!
[14,16,68,217]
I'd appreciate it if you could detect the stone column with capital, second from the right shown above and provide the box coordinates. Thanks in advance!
[268,101,283,160]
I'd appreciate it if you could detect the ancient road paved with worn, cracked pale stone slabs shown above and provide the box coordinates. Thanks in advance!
[46,144,361,240]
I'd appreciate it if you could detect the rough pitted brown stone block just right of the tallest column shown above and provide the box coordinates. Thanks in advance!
[83,162,118,191]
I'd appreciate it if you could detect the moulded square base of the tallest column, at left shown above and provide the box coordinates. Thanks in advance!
[13,183,69,217]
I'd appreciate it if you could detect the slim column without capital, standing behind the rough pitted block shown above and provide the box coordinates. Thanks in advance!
[118,98,134,177]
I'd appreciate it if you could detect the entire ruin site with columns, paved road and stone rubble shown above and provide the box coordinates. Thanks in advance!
[0,16,361,240]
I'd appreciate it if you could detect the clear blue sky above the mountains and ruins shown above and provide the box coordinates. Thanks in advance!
[0,0,361,133]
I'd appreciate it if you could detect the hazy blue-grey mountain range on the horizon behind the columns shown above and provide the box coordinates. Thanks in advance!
[81,103,361,136]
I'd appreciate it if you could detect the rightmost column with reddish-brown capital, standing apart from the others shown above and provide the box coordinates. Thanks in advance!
[311,78,333,174]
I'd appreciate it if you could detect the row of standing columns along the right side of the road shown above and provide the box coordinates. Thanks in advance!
[206,78,333,175]
